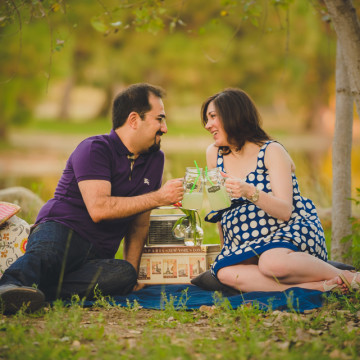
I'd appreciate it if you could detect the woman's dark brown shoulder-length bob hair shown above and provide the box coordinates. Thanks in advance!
[201,88,270,155]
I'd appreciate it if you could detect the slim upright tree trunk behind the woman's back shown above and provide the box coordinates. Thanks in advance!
[331,40,354,264]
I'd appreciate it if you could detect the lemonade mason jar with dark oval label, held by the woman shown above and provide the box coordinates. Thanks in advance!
[205,168,231,210]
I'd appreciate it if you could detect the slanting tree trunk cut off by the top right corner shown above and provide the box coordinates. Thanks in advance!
[324,0,360,115]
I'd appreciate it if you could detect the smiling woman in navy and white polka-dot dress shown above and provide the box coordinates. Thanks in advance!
[201,89,360,292]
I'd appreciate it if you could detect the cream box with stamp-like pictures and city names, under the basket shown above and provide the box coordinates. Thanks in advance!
[138,244,220,284]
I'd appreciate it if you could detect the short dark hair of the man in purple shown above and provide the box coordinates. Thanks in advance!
[112,83,165,130]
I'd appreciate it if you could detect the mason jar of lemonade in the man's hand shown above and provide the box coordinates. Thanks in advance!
[182,167,204,210]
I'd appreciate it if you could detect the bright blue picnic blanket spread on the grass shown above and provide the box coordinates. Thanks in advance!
[84,285,326,313]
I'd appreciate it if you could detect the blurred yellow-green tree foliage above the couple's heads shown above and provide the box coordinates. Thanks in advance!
[0,0,344,136]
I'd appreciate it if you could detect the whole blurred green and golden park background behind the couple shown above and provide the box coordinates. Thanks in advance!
[0,0,360,233]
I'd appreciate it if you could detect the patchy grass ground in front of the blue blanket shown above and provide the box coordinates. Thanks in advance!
[0,294,360,360]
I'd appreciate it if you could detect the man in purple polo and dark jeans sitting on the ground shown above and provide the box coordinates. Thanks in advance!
[0,84,183,313]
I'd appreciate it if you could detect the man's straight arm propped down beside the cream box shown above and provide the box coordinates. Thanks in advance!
[124,211,150,273]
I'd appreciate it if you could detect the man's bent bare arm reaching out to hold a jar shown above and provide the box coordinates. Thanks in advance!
[79,179,184,222]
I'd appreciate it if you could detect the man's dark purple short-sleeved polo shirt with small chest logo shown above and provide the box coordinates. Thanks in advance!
[36,130,164,258]
